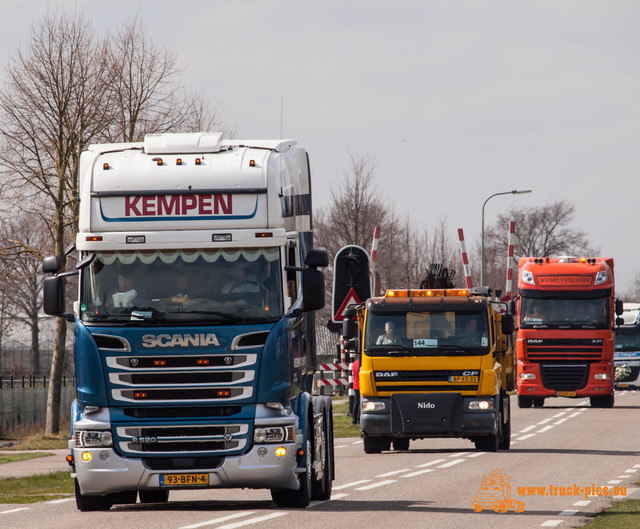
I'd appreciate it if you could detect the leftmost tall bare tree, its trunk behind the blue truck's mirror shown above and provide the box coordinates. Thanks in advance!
[0,13,111,434]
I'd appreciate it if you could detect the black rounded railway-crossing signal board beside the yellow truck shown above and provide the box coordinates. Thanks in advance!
[332,245,371,323]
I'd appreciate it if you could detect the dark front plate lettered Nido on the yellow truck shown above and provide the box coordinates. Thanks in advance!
[391,393,462,433]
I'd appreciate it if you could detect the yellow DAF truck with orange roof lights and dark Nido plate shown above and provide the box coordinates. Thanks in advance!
[343,287,515,454]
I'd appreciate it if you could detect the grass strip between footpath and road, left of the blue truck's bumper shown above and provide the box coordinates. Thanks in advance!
[0,471,74,503]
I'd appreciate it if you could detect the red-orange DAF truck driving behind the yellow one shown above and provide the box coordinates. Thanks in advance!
[515,257,622,408]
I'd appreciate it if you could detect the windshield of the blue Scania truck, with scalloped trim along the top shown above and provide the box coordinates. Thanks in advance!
[80,248,283,324]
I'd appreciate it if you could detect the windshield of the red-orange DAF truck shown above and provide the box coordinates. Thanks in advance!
[520,297,610,329]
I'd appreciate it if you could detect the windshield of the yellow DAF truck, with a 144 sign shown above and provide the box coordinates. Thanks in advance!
[365,312,490,356]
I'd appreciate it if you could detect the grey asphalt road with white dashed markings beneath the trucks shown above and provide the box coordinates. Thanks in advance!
[0,392,640,529]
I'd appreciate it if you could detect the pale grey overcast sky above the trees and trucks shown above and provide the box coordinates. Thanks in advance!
[0,0,640,291]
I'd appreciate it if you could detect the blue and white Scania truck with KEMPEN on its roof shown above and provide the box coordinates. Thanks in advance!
[43,133,334,511]
